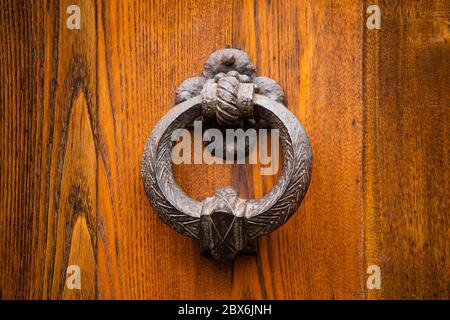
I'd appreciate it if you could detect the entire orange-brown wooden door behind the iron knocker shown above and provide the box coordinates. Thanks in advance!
[0,0,450,299]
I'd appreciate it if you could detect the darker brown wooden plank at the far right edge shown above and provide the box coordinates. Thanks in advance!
[364,0,450,299]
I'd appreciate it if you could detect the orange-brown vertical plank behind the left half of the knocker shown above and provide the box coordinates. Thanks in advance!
[97,1,236,299]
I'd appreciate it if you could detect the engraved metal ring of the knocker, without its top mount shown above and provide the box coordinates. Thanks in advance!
[142,48,312,262]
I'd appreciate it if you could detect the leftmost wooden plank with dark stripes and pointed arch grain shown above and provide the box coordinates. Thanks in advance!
[0,1,96,299]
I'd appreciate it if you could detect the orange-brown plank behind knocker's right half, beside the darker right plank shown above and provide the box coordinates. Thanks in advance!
[233,1,365,299]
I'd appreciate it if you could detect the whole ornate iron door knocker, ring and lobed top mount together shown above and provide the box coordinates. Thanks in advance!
[142,49,312,262]
